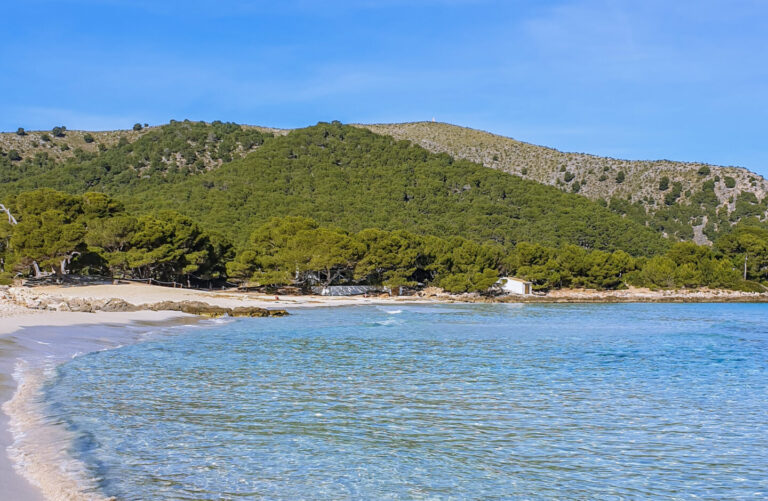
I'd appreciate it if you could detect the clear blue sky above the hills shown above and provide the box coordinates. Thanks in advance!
[0,0,768,176]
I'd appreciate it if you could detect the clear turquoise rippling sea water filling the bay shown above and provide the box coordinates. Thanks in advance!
[45,304,768,500]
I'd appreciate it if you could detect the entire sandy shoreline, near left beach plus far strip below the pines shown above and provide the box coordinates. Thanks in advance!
[0,284,768,501]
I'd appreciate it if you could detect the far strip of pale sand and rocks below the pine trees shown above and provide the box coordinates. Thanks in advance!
[0,283,768,316]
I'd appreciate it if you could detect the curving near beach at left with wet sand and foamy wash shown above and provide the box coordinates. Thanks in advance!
[0,311,200,501]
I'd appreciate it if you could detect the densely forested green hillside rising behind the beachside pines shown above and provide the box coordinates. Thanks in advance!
[0,122,667,255]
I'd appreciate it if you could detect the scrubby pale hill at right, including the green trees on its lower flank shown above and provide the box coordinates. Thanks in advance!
[358,122,768,243]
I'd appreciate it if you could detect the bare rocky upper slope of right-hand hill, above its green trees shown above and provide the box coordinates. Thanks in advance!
[359,122,768,210]
